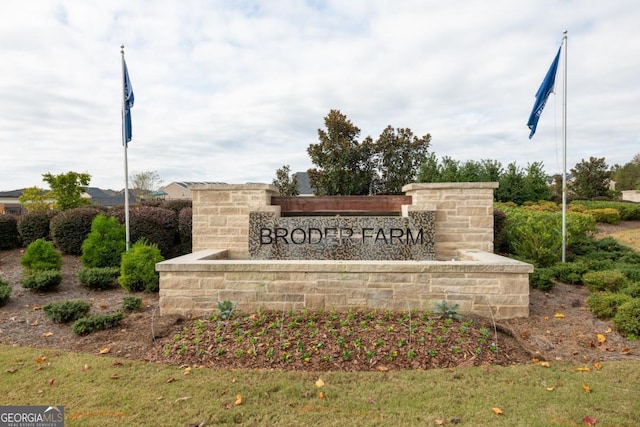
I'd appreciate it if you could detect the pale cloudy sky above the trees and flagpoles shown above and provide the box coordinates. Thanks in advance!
[0,0,640,191]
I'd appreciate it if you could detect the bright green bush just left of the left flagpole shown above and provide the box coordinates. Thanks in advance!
[80,214,126,267]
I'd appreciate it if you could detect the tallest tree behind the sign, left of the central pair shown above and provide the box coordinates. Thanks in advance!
[307,110,375,196]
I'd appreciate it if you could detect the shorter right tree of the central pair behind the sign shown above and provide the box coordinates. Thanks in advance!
[373,126,431,194]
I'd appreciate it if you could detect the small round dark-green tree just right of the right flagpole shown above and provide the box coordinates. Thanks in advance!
[569,157,611,199]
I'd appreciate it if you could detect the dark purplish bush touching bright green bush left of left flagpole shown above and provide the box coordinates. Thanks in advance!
[51,207,100,255]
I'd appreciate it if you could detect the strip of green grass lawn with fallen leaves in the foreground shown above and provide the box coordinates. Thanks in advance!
[0,345,640,427]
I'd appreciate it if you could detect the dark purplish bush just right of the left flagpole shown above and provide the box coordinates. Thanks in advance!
[114,206,178,258]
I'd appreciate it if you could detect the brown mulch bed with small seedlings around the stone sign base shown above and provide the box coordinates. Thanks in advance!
[0,224,640,371]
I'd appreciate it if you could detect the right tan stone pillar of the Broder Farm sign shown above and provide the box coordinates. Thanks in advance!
[402,182,498,260]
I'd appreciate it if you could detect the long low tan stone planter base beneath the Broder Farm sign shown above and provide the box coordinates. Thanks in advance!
[156,250,533,319]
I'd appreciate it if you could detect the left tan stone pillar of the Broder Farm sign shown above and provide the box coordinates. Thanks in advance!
[191,184,280,259]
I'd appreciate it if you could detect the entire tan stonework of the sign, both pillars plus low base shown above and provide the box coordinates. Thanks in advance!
[156,183,533,319]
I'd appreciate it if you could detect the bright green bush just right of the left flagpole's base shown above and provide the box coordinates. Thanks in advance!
[119,240,164,292]
